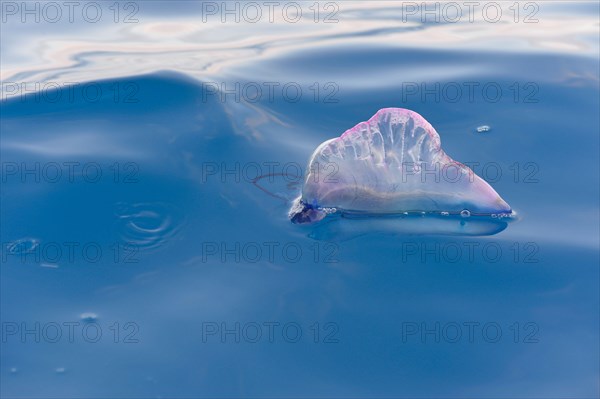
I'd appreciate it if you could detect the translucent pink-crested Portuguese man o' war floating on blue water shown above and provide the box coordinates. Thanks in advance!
[289,108,514,235]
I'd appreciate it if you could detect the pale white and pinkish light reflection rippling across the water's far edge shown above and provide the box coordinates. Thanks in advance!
[0,1,598,89]
